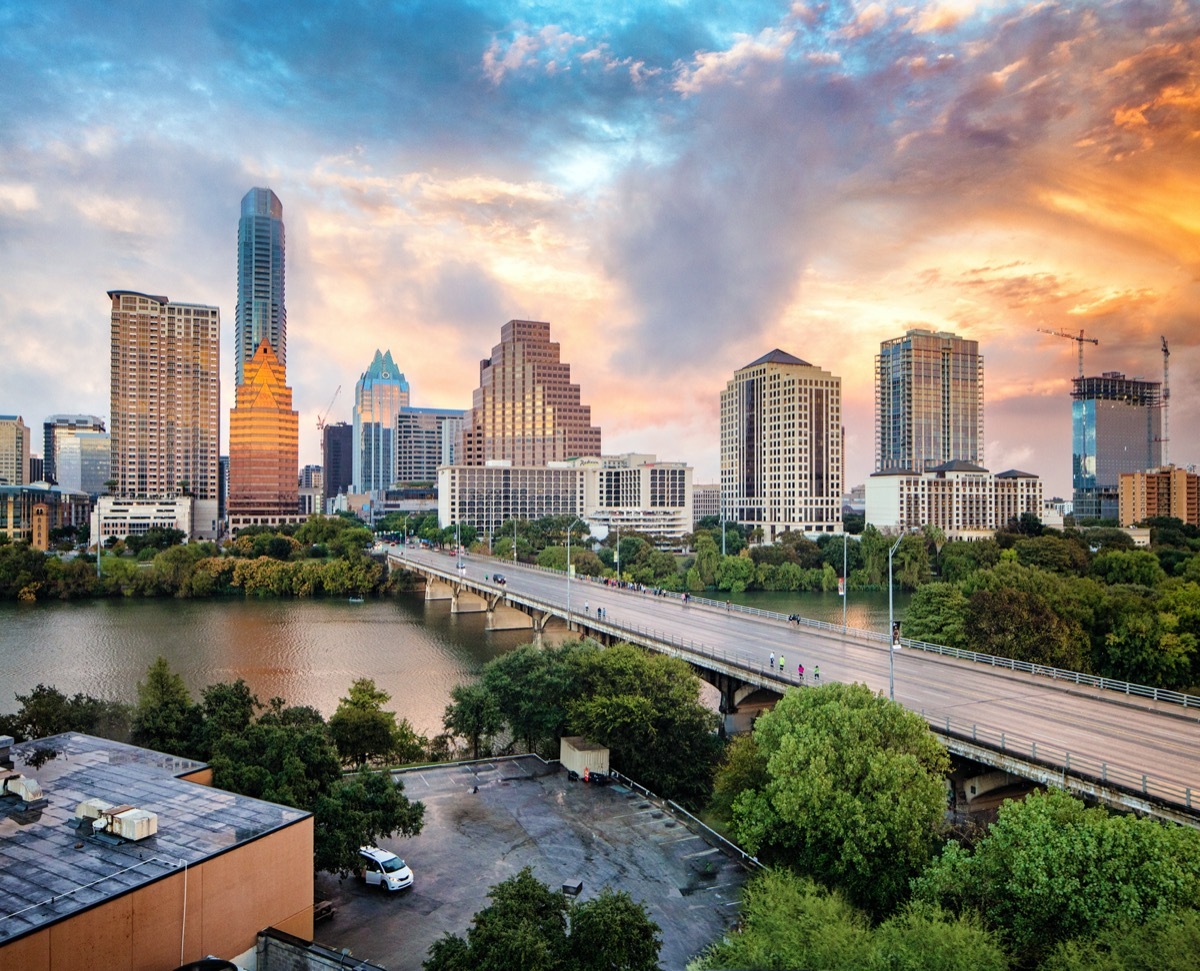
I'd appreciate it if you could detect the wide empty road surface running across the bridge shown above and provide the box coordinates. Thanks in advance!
[393,547,1200,802]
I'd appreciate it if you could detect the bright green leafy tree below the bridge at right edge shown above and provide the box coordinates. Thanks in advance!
[913,790,1200,963]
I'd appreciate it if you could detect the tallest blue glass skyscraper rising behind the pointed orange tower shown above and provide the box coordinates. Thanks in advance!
[234,188,288,384]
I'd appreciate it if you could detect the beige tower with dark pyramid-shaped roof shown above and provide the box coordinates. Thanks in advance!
[721,349,842,543]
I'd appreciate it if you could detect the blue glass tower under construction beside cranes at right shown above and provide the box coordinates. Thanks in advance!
[1070,371,1163,522]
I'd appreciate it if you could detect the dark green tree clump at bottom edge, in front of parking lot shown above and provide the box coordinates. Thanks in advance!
[422,867,661,971]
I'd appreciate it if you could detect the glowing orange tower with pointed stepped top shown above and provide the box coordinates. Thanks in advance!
[226,337,300,531]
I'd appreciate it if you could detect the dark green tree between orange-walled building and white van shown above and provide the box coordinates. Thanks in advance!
[313,769,425,876]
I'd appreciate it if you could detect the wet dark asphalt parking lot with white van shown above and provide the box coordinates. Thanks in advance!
[314,756,746,971]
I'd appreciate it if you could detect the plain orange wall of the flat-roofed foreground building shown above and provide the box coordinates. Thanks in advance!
[0,816,313,971]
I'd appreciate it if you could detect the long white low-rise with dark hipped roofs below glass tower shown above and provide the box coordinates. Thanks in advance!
[866,461,1043,539]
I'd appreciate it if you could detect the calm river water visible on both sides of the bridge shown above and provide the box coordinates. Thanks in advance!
[0,583,908,736]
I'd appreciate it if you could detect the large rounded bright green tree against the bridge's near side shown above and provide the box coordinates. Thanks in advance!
[733,684,949,913]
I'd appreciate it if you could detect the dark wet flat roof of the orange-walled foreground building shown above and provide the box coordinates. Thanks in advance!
[0,732,308,946]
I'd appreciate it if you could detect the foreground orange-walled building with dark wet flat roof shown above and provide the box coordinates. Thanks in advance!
[0,733,313,971]
